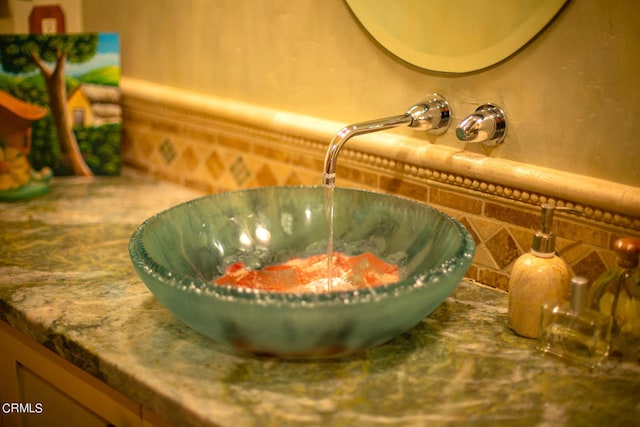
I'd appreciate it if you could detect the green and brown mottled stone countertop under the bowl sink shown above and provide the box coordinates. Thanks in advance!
[0,173,640,427]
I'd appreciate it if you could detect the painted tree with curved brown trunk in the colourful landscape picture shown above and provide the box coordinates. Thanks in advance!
[0,34,98,175]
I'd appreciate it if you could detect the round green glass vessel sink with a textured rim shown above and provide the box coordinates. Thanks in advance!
[129,187,475,358]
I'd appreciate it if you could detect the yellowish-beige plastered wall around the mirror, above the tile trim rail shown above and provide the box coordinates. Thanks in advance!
[83,0,640,186]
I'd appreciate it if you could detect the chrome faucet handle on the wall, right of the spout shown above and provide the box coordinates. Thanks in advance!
[456,104,507,146]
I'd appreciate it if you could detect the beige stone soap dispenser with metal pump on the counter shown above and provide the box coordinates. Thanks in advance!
[508,203,571,338]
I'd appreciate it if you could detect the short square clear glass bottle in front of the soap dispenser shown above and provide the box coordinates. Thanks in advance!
[536,277,611,369]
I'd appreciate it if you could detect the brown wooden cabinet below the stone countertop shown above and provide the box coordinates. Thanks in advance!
[0,321,167,427]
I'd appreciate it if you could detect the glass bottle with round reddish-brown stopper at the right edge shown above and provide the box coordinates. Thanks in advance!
[589,237,640,362]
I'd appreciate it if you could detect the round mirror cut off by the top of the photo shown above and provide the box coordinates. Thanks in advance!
[345,0,568,73]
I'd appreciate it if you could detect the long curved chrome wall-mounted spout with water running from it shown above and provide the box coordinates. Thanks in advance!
[322,93,451,187]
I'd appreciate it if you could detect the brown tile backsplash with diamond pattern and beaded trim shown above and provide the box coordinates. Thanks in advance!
[122,97,640,290]
